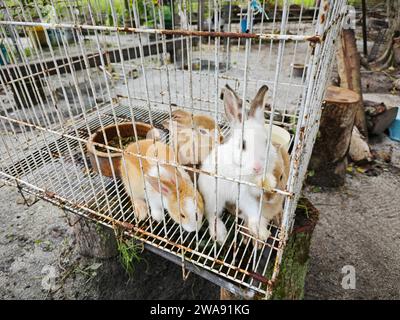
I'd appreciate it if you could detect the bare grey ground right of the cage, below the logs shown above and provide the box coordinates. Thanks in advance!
[305,167,400,299]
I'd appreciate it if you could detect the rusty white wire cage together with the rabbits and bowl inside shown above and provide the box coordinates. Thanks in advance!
[0,0,346,297]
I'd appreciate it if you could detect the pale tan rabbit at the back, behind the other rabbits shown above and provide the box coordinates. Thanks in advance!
[162,110,222,165]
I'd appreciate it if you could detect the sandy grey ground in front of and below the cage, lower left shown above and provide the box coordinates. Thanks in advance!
[0,186,219,300]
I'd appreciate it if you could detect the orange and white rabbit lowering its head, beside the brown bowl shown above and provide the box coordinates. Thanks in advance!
[120,139,204,232]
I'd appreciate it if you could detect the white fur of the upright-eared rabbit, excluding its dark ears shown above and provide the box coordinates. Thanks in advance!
[198,86,277,244]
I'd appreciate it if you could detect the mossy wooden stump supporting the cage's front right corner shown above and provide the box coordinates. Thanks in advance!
[220,198,319,300]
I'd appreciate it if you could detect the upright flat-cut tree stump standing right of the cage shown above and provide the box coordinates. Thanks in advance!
[307,86,359,187]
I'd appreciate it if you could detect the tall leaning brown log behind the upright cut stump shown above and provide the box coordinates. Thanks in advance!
[337,29,368,137]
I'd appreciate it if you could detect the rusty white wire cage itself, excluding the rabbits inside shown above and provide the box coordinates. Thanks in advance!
[0,0,346,298]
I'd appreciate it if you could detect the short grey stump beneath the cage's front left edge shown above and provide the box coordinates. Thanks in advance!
[72,215,118,259]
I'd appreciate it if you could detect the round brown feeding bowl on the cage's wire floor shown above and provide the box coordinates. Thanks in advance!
[86,122,153,177]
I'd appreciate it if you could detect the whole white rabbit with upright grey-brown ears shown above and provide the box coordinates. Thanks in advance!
[198,85,277,244]
